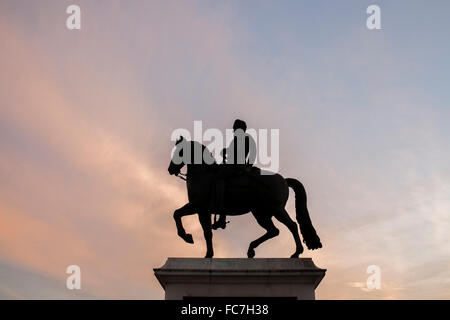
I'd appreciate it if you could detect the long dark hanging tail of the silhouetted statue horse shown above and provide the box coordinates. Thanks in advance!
[286,178,322,250]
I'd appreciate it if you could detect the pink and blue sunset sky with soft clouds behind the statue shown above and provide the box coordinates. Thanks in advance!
[0,0,450,299]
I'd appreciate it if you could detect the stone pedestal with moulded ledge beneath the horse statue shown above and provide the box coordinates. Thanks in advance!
[154,258,326,300]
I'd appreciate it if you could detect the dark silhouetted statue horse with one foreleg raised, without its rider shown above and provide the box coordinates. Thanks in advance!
[168,137,322,258]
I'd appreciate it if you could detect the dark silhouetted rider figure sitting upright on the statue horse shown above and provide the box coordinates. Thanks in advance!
[212,119,256,229]
